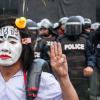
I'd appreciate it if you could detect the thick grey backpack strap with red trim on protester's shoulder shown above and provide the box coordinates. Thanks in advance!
[26,58,49,100]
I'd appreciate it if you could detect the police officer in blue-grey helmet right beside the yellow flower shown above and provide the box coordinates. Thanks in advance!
[26,19,44,58]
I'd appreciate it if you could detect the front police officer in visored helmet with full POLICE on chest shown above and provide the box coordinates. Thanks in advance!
[58,16,94,100]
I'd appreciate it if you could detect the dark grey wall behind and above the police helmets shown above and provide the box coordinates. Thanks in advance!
[0,0,100,22]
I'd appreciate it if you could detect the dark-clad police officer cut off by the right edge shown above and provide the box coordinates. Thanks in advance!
[91,26,100,100]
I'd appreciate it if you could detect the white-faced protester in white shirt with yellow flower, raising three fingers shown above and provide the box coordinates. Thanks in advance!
[0,17,79,100]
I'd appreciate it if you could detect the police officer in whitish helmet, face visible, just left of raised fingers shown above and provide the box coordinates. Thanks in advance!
[39,19,58,62]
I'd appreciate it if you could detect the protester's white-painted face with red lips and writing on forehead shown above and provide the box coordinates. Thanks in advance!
[0,26,22,66]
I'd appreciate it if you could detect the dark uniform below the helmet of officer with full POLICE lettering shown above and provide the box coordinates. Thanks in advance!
[58,35,94,100]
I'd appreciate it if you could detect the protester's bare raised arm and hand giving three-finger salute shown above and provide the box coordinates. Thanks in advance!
[50,42,79,100]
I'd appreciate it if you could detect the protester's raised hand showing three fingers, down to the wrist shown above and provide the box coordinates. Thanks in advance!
[50,42,68,77]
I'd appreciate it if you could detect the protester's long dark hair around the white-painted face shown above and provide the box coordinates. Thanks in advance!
[0,16,33,70]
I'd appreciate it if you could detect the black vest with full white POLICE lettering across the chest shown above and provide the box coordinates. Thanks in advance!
[59,36,86,75]
